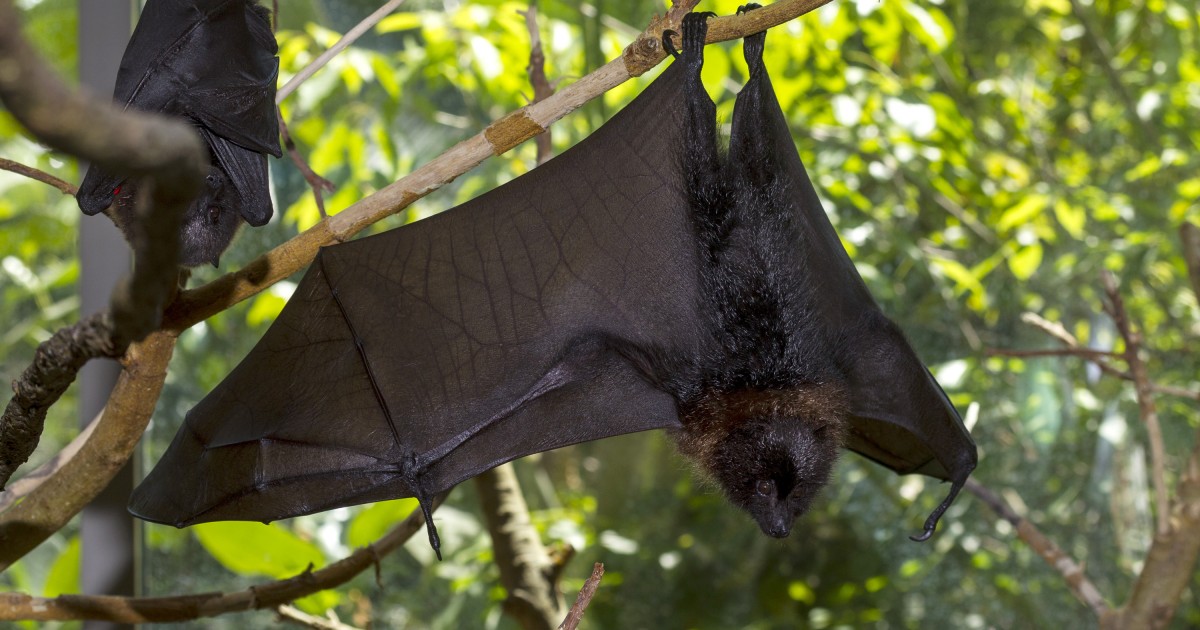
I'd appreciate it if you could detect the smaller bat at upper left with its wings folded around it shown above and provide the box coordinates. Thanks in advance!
[76,0,282,266]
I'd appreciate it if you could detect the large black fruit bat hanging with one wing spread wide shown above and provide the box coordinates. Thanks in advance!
[130,14,976,550]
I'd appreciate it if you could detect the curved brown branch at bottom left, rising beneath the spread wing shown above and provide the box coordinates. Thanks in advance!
[0,494,445,624]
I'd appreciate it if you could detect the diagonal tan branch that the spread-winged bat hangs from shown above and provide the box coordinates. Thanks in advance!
[163,0,829,331]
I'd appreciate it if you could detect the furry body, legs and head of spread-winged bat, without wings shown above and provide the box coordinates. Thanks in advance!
[672,13,848,538]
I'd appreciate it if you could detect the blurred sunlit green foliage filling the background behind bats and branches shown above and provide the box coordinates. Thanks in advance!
[0,0,1200,628]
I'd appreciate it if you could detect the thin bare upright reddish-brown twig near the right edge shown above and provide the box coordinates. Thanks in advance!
[1100,271,1171,535]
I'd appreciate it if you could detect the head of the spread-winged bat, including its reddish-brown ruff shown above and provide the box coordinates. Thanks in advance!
[679,384,846,538]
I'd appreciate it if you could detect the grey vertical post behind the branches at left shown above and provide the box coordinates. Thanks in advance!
[78,0,138,630]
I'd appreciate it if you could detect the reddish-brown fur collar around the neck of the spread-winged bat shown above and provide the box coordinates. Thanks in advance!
[673,382,850,475]
